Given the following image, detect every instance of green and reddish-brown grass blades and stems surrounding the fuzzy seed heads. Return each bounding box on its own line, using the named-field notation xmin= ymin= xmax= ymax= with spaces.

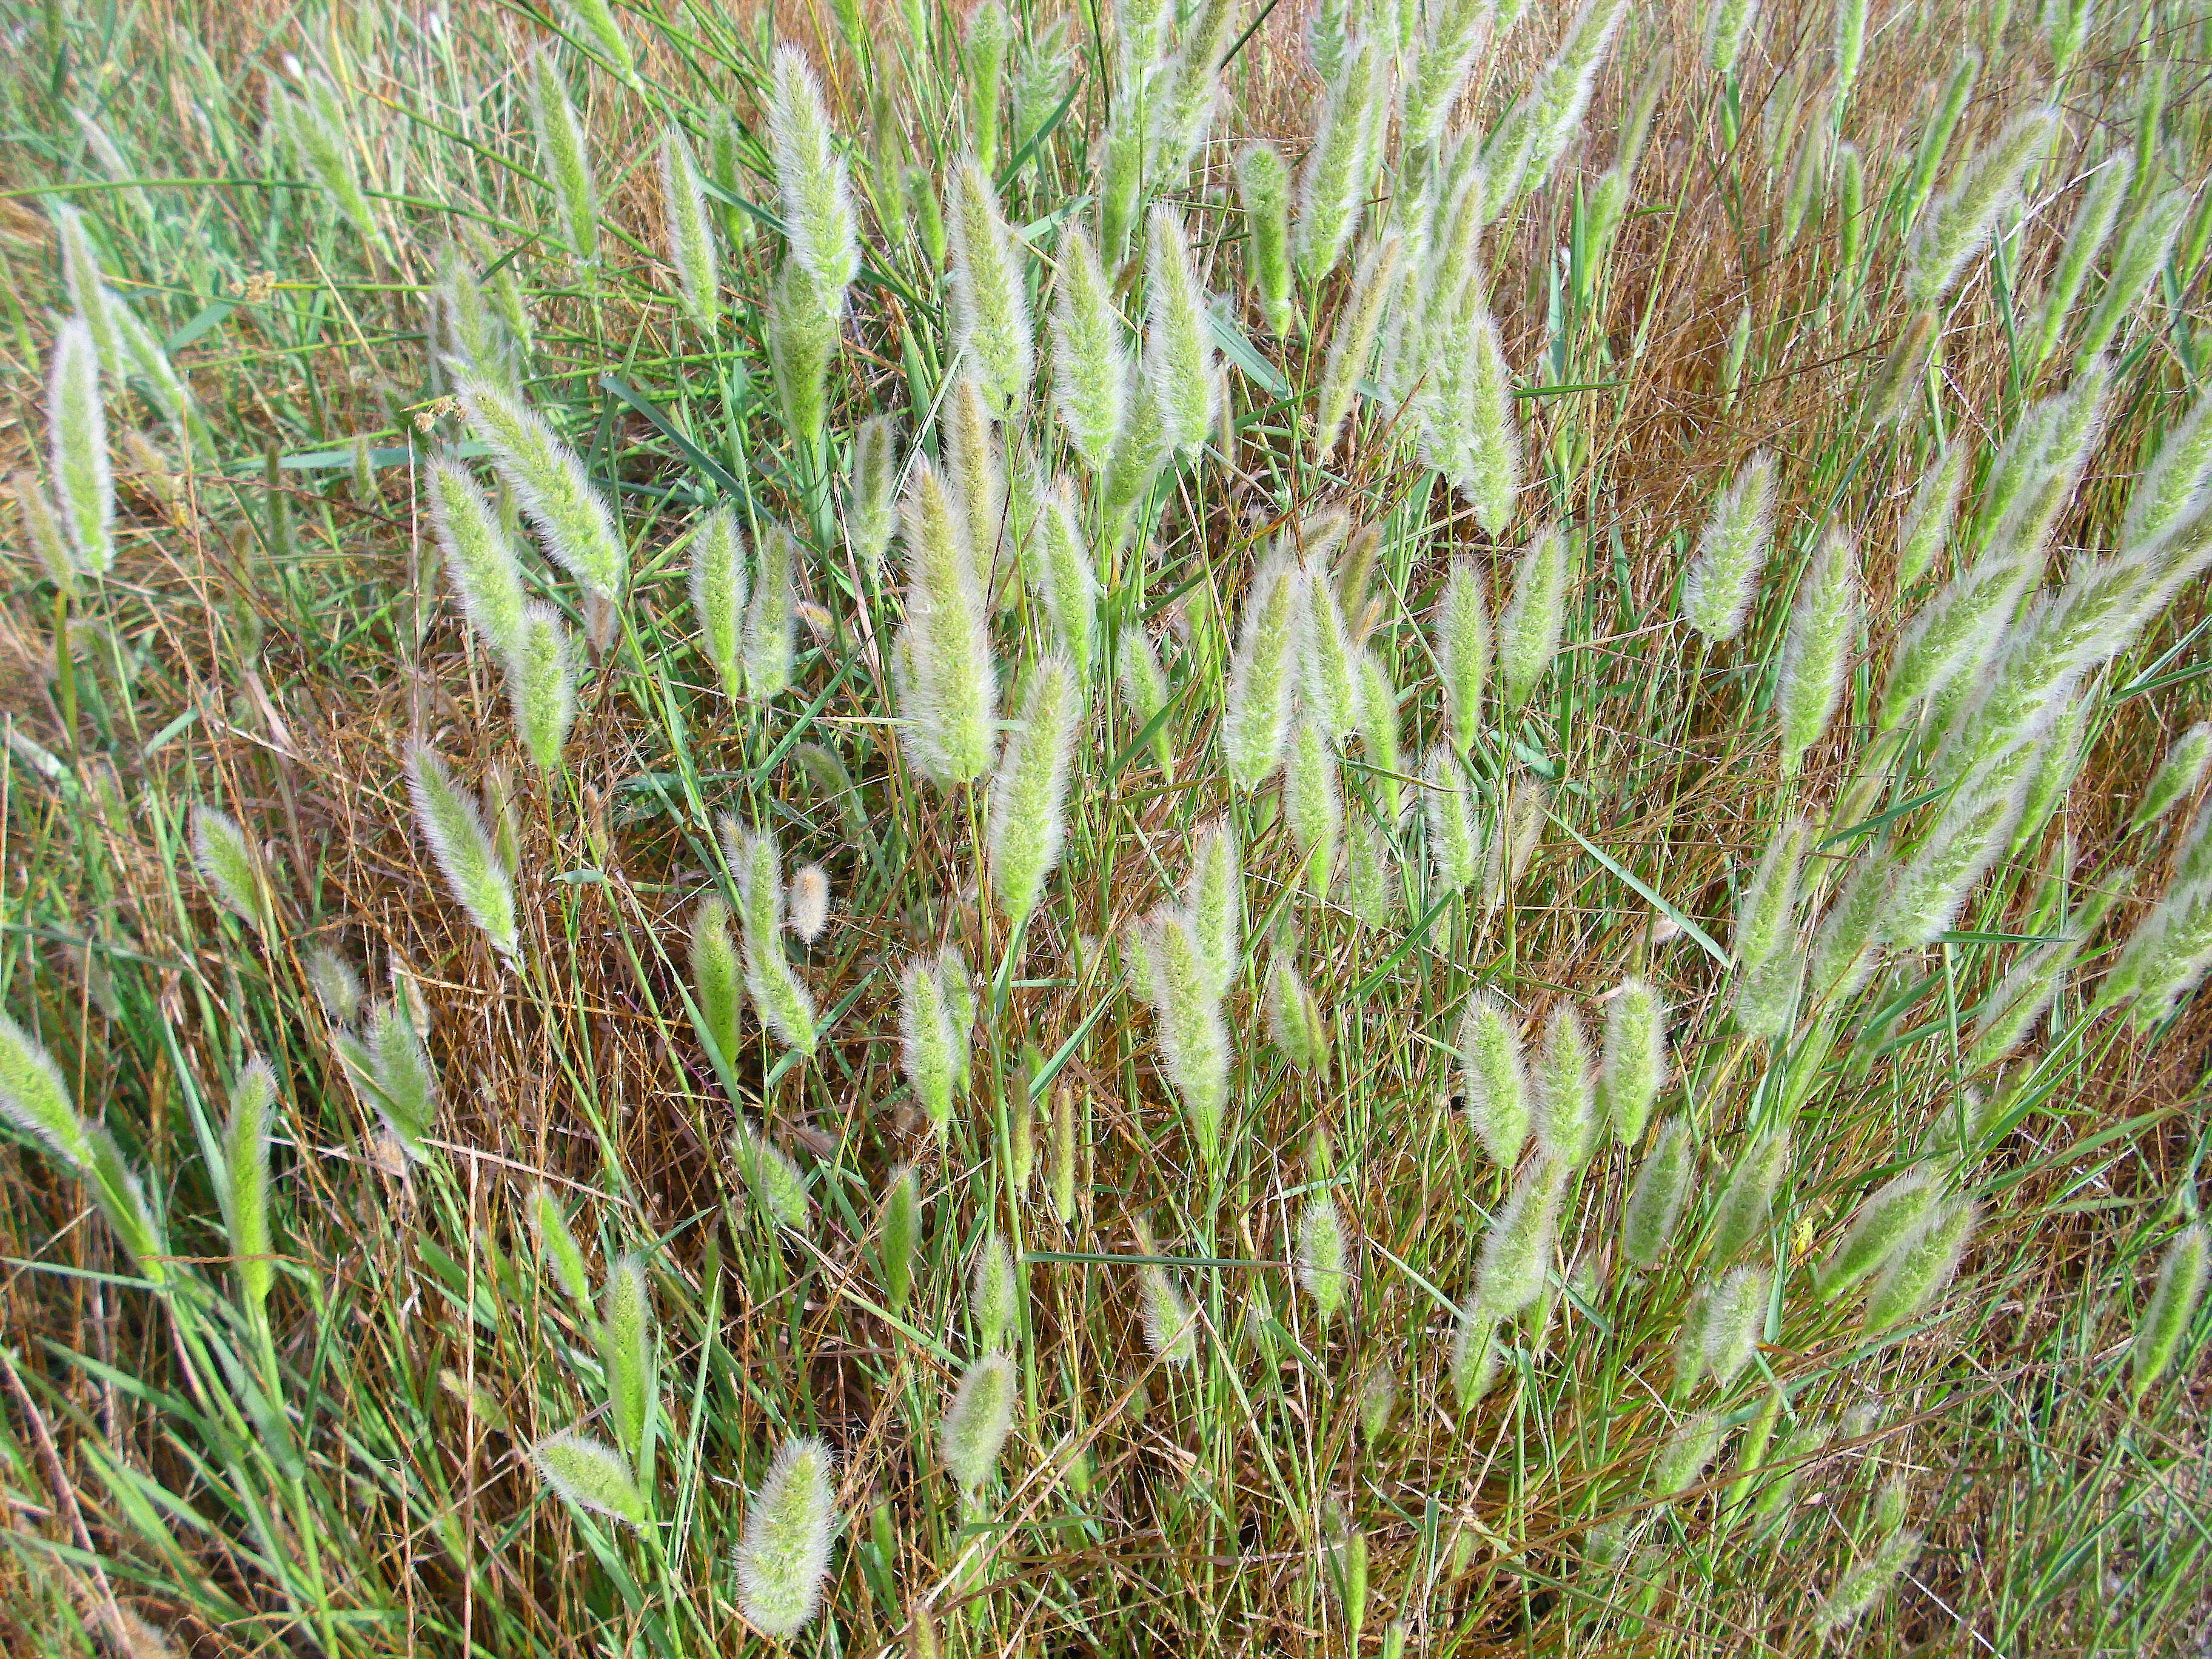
xmin=0 ymin=0 xmax=2212 ymax=1657
